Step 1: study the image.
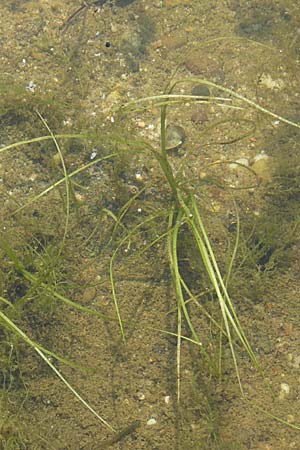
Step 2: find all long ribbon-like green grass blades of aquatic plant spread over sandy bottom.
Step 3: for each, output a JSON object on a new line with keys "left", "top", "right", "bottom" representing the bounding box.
{"left": 0, "top": 74, "right": 300, "bottom": 442}
